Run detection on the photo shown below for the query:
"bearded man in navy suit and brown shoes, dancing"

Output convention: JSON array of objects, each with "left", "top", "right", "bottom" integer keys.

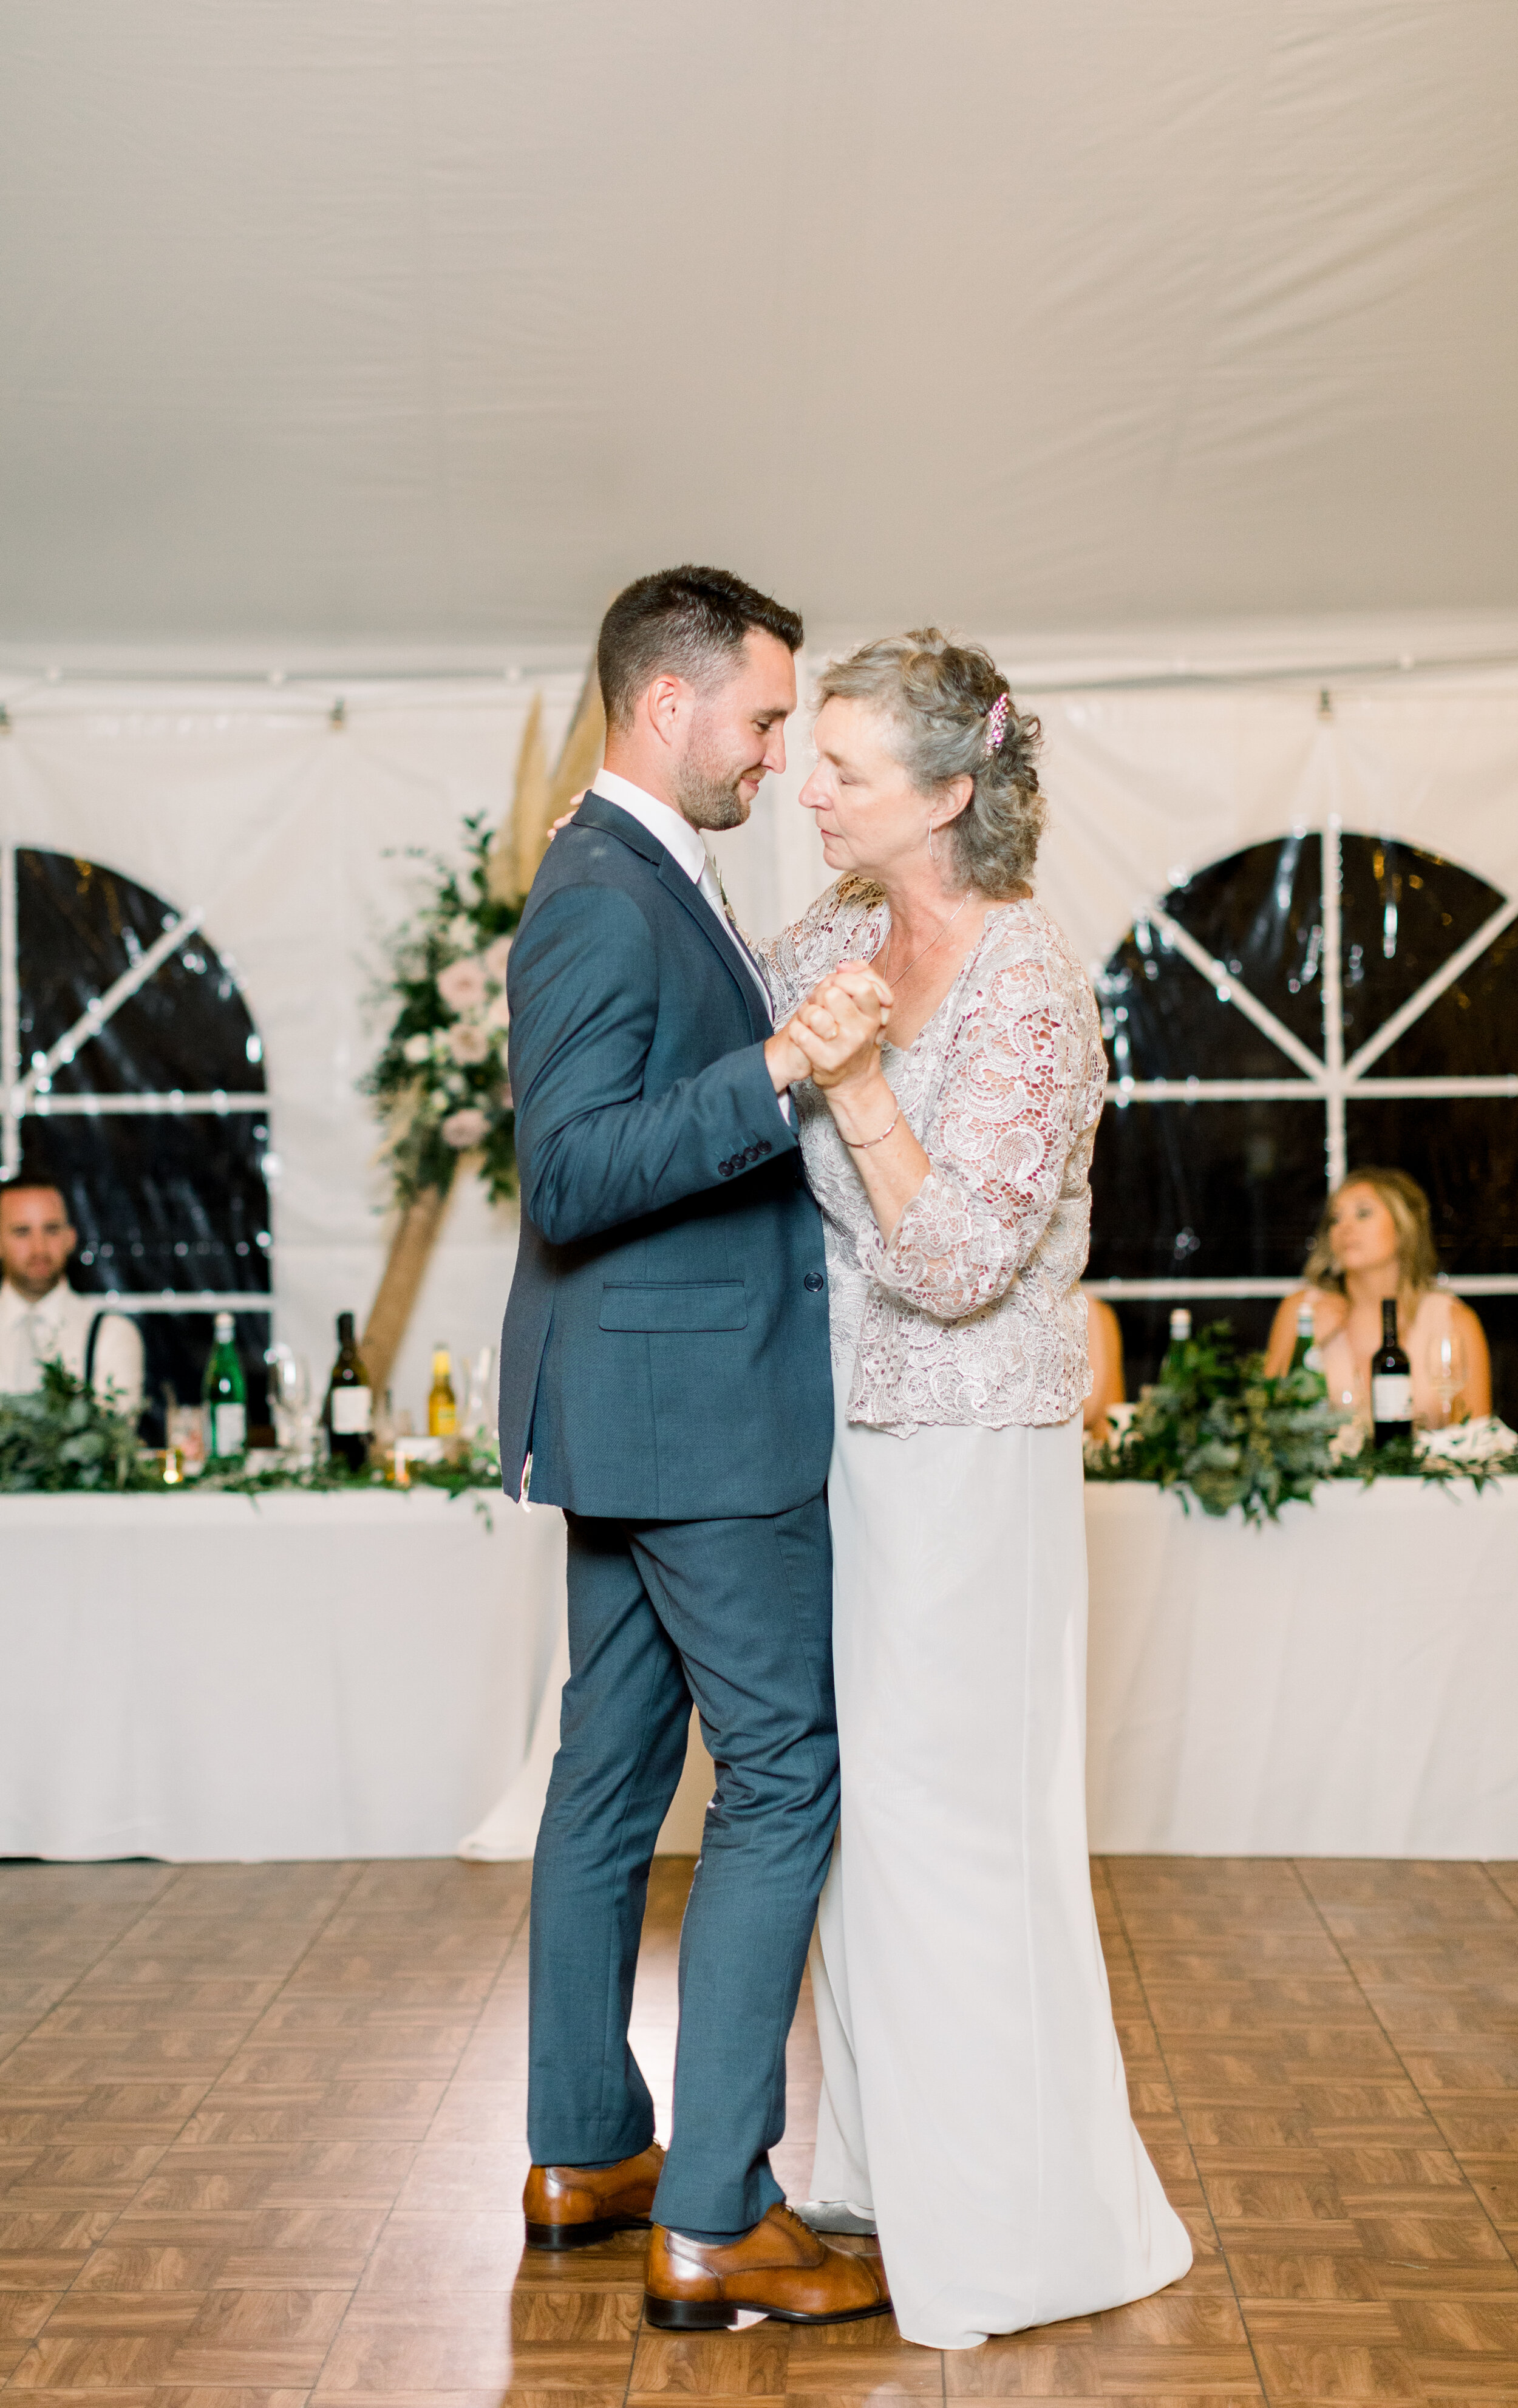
[{"left": 501, "top": 568, "right": 887, "bottom": 2331}]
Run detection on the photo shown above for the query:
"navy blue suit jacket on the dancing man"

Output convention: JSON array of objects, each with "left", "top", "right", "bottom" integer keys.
[{"left": 501, "top": 792, "right": 834, "bottom": 1522}]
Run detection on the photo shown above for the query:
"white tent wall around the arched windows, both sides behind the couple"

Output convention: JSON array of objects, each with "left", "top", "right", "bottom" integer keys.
[{"left": 0, "top": 626, "right": 1518, "bottom": 1411}]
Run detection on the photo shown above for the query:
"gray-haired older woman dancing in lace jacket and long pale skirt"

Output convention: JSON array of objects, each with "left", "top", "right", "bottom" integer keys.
[{"left": 766, "top": 628, "right": 1190, "bottom": 2348}]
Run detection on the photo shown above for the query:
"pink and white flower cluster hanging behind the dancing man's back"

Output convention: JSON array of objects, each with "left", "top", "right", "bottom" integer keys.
[{"left": 364, "top": 814, "right": 523, "bottom": 1209}]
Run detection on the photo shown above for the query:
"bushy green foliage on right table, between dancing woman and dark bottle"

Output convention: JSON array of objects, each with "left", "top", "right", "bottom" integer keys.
[{"left": 1087, "top": 1322, "right": 1342, "bottom": 1522}]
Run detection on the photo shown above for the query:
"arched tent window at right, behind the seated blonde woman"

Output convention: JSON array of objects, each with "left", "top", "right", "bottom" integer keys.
[{"left": 1089, "top": 823, "right": 1518, "bottom": 1418}]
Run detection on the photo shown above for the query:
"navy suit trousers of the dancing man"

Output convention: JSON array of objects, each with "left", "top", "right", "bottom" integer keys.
[{"left": 528, "top": 1495, "right": 839, "bottom": 2237}]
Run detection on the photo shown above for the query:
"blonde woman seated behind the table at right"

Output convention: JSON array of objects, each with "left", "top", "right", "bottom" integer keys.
[{"left": 1265, "top": 1168, "right": 1491, "bottom": 1430}]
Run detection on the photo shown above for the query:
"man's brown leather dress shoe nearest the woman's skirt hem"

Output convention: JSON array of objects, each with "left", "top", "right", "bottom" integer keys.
[{"left": 644, "top": 2208, "right": 891, "bottom": 2333}]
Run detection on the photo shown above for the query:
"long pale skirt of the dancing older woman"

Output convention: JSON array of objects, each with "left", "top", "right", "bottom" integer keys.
[{"left": 812, "top": 1421, "right": 1190, "bottom": 2350}]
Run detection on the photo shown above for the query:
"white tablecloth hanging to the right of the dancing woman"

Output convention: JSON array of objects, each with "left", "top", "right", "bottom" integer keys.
[{"left": 1087, "top": 1481, "right": 1518, "bottom": 1857}]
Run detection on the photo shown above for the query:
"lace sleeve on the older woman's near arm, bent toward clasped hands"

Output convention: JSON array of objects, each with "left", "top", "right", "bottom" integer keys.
[{"left": 860, "top": 954, "right": 1106, "bottom": 1322}]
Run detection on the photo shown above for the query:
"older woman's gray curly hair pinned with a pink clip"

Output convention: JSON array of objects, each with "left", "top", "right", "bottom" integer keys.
[{"left": 817, "top": 626, "right": 1046, "bottom": 900}]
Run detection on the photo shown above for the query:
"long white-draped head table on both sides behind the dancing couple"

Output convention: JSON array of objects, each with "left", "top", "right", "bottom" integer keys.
[{"left": 0, "top": 1481, "right": 1518, "bottom": 1862}]
